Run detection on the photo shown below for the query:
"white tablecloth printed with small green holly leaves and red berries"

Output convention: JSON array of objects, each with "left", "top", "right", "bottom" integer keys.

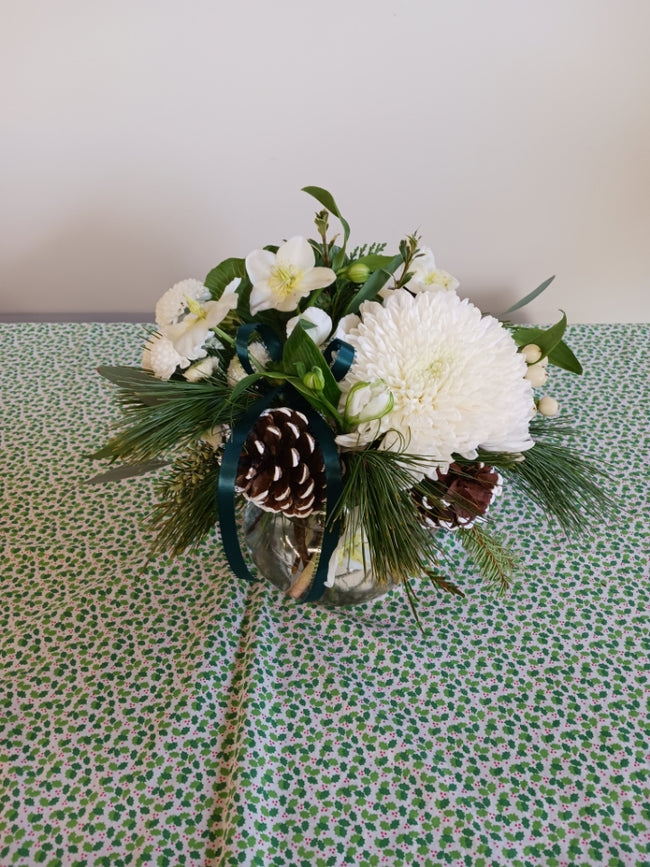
[{"left": 0, "top": 323, "right": 650, "bottom": 867}]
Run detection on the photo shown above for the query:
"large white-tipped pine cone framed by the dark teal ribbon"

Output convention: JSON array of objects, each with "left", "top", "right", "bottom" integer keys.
[{"left": 235, "top": 406, "right": 327, "bottom": 518}]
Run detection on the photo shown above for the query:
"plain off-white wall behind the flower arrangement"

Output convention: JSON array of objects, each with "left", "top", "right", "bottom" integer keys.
[{"left": 0, "top": 0, "right": 650, "bottom": 322}]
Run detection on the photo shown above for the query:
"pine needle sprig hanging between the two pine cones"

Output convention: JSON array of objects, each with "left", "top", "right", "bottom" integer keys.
[{"left": 332, "top": 449, "right": 439, "bottom": 583}]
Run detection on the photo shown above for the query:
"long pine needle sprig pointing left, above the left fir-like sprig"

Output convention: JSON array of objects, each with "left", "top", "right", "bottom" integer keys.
[{"left": 91, "top": 367, "right": 251, "bottom": 463}]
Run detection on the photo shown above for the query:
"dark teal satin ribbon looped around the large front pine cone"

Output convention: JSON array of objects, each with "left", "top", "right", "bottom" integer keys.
[{"left": 217, "top": 323, "right": 354, "bottom": 602}]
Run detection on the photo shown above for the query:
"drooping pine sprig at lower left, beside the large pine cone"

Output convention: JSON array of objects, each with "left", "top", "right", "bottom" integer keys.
[{"left": 149, "top": 442, "right": 220, "bottom": 557}]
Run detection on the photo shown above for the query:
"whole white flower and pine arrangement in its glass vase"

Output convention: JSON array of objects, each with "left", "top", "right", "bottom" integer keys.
[{"left": 93, "top": 187, "right": 609, "bottom": 602}]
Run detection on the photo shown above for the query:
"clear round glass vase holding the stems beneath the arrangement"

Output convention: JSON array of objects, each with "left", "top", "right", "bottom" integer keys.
[{"left": 243, "top": 502, "right": 395, "bottom": 607}]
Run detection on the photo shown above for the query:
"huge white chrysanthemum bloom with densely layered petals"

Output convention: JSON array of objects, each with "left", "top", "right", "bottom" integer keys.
[{"left": 341, "top": 289, "right": 534, "bottom": 468}]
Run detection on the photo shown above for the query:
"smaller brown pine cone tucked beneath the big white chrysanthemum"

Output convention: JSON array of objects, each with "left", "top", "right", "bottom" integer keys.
[{"left": 411, "top": 463, "right": 502, "bottom": 530}]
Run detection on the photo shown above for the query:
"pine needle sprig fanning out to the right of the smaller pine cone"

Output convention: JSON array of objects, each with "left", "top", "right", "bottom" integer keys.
[{"left": 502, "top": 419, "right": 617, "bottom": 535}]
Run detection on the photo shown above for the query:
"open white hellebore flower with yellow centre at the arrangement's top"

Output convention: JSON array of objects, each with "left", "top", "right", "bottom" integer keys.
[{"left": 246, "top": 235, "right": 336, "bottom": 313}]
